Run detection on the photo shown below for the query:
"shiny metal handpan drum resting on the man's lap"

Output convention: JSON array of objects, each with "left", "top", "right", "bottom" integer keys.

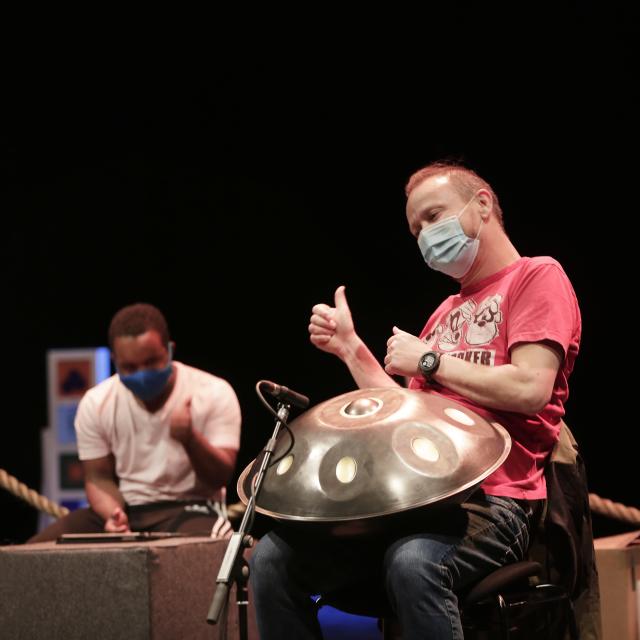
[{"left": 238, "top": 387, "right": 511, "bottom": 535}]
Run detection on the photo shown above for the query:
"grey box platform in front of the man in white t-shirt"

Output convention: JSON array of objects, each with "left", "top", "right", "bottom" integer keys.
[{"left": 0, "top": 538, "right": 258, "bottom": 640}]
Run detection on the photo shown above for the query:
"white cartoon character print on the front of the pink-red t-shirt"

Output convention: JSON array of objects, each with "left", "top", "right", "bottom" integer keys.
[{"left": 423, "top": 293, "right": 503, "bottom": 366}]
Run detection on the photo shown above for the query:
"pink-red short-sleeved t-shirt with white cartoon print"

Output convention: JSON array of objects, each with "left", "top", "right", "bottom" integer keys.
[{"left": 409, "top": 257, "right": 582, "bottom": 500}]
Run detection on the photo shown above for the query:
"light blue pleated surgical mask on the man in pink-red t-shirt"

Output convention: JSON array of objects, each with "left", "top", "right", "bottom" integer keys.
[{"left": 418, "top": 194, "right": 482, "bottom": 279}]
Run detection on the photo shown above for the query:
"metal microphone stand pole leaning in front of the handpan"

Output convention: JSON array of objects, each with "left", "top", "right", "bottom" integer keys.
[{"left": 207, "top": 402, "right": 291, "bottom": 640}]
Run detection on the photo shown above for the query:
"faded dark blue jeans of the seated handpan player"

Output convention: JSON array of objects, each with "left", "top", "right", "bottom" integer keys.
[{"left": 250, "top": 492, "right": 532, "bottom": 640}]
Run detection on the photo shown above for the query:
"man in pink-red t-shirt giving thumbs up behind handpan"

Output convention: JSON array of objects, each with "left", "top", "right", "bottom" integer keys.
[{"left": 252, "top": 163, "right": 581, "bottom": 639}]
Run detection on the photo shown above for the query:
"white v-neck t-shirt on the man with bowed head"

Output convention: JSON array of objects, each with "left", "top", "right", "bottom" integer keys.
[{"left": 75, "top": 361, "right": 241, "bottom": 504}]
